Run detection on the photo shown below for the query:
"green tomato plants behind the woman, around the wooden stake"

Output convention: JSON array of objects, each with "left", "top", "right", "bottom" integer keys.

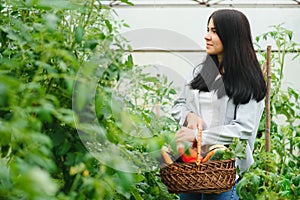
[{"left": 237, "top": 24, "right": 300, "bottom": 200}]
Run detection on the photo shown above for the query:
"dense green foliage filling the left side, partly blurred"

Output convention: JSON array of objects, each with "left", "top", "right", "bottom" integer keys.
[{"left": 0, "top": 0, "right": 176, "bottom": 200}]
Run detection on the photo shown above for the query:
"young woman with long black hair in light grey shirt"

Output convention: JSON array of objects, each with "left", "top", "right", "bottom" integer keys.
[{"left": 173, "top": 9, "right": 266, "bottom": 200}]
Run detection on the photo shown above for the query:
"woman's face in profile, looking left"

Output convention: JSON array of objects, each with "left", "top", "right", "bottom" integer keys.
[{"left": 204, "top": 18, "right": 223, "bottom": 62}]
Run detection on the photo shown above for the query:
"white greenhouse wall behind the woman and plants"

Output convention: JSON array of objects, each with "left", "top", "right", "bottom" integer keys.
[{"left": 114, "top": 1, "right": 300, "bottom": 91}]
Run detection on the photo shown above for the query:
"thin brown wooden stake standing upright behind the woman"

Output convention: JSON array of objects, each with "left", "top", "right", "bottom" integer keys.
[{"left": 266, "top": 45, "right": 272, "bottom": 152}]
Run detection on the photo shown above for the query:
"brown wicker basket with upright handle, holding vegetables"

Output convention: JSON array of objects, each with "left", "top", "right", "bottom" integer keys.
[{"left": 160, "top": 129, "right": 236, "bottom": 193}]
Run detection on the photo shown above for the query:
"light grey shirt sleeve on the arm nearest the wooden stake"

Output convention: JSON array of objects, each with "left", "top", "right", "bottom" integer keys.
[{"left": 202, "top": 99, "right": 264, "bottom": 146}]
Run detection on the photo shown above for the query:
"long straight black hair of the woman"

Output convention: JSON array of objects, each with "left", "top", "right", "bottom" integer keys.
[{"left": 190, "top": 9, "right": 266, "bottom": 105}]
